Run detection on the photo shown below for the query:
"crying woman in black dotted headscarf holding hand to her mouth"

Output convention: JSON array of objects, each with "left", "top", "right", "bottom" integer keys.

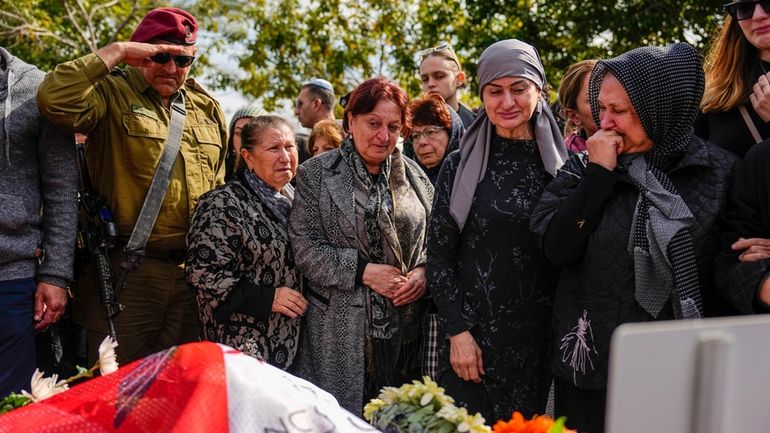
[{"left": 532, "top": 44, "right": 734, "bottom": 433}]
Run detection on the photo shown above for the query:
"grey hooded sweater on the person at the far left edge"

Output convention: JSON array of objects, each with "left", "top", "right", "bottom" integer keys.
[{"left": 0, "top": 47, "right": 78, "bottom": 287}]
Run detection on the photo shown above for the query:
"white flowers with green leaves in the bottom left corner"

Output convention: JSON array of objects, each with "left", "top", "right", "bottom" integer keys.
[{"left": 0, "top": 336, "right": 118, "bottom": 414}]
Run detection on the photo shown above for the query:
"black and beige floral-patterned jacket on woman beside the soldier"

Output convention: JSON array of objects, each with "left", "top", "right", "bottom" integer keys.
[{"left": 186, "top": 179, "right": 302, "bottom": 369}]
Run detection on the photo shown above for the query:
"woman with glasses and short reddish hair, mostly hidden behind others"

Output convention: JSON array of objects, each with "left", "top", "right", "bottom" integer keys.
[{"left": 409, "top": 93, "right": 465, "bottom": 185}]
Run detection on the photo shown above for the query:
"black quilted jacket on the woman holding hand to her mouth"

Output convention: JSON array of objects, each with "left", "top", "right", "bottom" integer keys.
[{"left": 531, "top": 136, "right": 735, "bottom": 389}]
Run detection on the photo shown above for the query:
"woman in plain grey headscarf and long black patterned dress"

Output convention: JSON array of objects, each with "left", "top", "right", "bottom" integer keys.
[{"left": 428, "top": 39, "right": 567, "bottom": 420}]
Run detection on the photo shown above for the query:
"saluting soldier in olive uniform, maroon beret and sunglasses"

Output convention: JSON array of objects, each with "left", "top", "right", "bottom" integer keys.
[{"left": 37, "top": 8, "right": 227, "bottom": 363}]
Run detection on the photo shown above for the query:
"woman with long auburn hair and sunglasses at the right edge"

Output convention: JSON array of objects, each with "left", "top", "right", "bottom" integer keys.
[{"left": 695, "top": 0, "right": 770, "bottom": 158}]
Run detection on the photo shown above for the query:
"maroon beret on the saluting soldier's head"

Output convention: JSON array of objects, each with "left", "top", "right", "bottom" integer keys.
[{"left": 131, "top": 8, "right": 198, "bottom": 45}]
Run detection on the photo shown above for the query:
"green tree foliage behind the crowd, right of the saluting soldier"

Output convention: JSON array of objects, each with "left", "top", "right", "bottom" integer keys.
[{"left": 194, "top": 0, "right": 723, "bottom": 108}]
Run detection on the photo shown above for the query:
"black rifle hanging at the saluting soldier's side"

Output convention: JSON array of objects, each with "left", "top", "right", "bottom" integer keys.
[{"left": 75, "top": 139, "right": 125, "bottom": 341}]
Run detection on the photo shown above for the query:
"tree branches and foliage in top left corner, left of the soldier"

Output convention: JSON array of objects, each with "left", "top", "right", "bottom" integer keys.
[{"left": 0, "top": 0, "right": 160, "bottom": 70}]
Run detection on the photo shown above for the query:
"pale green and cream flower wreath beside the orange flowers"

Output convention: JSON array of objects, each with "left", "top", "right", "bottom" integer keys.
[{"left": 364, "top": 376, "right": 491, "bottom": 433}]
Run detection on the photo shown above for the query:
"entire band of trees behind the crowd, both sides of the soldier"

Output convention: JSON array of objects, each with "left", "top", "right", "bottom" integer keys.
[{"left": 0, "top": 0, "right": 724, "bottom": 110}]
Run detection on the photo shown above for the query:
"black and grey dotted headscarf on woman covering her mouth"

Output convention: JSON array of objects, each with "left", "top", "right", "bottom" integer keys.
[{"left": 588, "top": 43, "right": 704, "bottom": 318}]
